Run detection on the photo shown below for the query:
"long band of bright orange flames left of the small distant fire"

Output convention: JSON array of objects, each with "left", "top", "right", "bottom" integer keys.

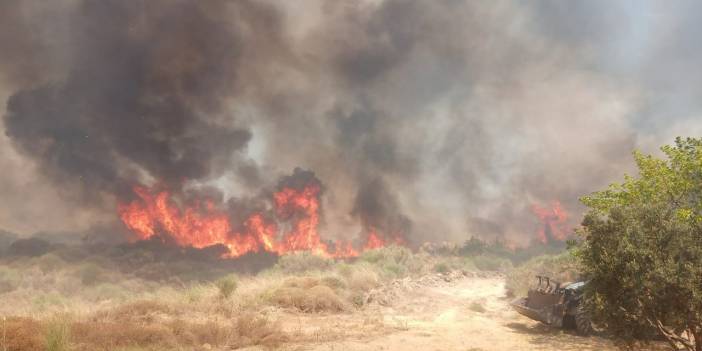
[{"left": 118, "top": 184, "right": 404, "bottom": 258}]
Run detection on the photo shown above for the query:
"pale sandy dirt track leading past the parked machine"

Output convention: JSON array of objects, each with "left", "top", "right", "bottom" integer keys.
[{"left": 280, "top": 277, "right": 632, "bottom": 351}]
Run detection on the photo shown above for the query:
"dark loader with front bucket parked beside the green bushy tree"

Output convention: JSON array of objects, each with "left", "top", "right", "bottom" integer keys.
[{"left": 511, "top": 276, "right": 593, "bottom": 336}]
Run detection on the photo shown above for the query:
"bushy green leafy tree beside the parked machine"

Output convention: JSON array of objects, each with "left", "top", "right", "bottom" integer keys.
[{"left": 576, "top": 138, "right": 702, "bottom": 350}]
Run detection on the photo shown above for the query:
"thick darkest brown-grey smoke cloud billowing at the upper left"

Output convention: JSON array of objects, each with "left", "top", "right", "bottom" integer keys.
[{"left": 5, "top": 1, "right": 288, "bottom": 199}]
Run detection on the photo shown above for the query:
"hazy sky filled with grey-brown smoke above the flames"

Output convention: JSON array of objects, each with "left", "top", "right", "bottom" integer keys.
[{"left": 0, "top": 0, "right": 702, "bottom": 243}]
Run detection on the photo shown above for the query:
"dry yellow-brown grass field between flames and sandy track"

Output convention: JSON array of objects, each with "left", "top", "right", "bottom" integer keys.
[{"left": 0, "top": 248, "right": 496, "bottom": 351}]
